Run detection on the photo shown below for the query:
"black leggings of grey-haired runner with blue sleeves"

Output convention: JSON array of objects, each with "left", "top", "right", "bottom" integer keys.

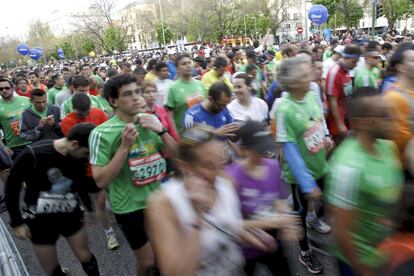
[{"left": 290, "top": 178, "right": 324, "bottom": 251}]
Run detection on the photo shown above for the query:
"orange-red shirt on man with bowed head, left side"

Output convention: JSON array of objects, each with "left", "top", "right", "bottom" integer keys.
[{"left": 60, "top": 107, "right": 108, "bottom": 136}]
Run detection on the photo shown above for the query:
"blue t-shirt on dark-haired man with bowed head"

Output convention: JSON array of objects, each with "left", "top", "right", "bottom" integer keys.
[{"left": 184, "top": 103, "right": 233, "bottom": 129}]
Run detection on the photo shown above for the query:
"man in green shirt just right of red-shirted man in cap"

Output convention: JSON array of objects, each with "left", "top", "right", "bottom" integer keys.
[{"left": 354, "top": 48, "right": 381, "bottom": 88}]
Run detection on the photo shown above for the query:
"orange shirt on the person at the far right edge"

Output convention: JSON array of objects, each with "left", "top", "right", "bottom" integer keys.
[{"left": 384, "top": 84, "right": 414, "bottom": 164}]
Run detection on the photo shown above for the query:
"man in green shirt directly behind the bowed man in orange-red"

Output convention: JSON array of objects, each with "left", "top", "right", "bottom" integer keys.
[{"left": 60, "top": 75, "right": 104, "bottom": 119}]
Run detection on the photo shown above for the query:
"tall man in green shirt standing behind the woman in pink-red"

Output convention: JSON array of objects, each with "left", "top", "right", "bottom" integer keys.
[{"left": 166, "top": 54, "right": 206, "bottom": 135}]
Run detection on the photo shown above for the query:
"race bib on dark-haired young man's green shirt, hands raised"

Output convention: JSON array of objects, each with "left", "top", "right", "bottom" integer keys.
[{"left": 128, "top": 152, "right": 167, "bottom": 186}]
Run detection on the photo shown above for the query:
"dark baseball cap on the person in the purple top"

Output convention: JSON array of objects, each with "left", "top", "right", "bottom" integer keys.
[{"left": 236, "top": 120, "right": 276, "bottom": 154}]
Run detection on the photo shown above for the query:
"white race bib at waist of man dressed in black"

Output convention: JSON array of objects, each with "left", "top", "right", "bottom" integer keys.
[{"left": 36, "top": 192, "right": 79, "bottom": 214}]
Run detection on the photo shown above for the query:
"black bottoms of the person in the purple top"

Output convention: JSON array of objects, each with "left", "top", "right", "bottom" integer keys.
[{"left": 244, "top": 242, "right": 291, "bottom": 276}]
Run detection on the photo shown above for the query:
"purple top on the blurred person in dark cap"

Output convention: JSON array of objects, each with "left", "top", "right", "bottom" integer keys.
[{"left": 225, "top": 158, "right": 287, "bottom": 258}]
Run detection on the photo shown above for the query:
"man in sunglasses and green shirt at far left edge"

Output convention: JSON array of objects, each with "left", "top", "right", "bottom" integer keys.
[{"left": 0, "top": 79, "right": 31, "bottom": 158}]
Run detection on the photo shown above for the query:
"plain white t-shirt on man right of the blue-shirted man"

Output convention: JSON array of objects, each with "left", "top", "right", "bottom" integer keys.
[{"left": 227, "top": 97, "right": 269, "bottom": 122}]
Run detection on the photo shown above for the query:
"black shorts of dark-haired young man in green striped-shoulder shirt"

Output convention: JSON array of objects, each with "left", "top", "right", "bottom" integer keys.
[{"left": 115, "top": 209, "right": 148, "bottom": 251}]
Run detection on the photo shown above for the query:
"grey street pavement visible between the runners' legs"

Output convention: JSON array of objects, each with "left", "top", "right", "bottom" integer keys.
[{"left": 0, "top": 210, "right": 338, "bottom": 276}]
